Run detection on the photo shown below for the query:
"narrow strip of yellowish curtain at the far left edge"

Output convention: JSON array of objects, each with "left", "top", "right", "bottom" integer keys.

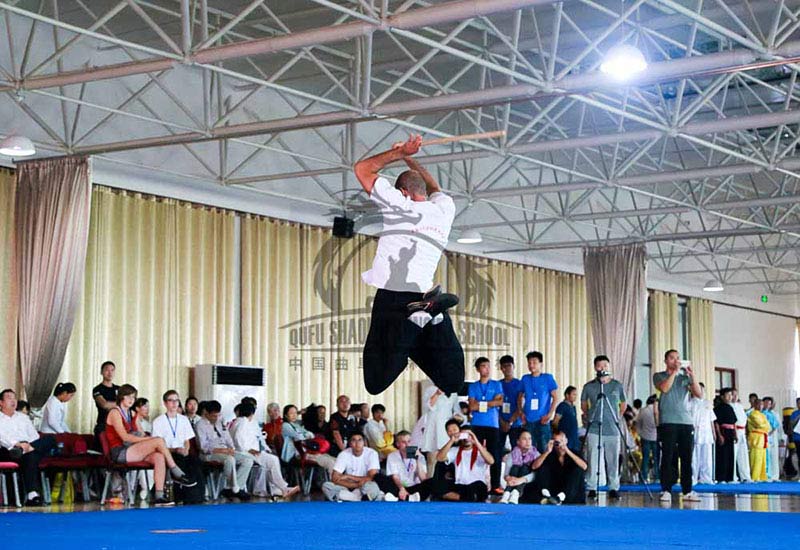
[{"left": 0, "top": 168, "right": 20, "bottom": 390}]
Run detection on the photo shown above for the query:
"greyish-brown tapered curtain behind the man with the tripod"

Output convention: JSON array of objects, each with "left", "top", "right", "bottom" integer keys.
[{"left": 583, "top": 244, "right": 647, "bottom": 395}]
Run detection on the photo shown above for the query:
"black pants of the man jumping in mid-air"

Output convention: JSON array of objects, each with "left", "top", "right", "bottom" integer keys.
[{"left": 363, "top": 289, "right": 464, "bottom": 395}]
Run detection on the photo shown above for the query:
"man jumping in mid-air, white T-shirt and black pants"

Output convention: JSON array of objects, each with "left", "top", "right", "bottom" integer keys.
[{"left": 355, "top": 136, "right": 464, "bottom": 395}]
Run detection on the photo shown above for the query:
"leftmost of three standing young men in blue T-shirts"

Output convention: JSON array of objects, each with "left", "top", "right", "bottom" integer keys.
[{"left": 468, "top": 357, "right": 503, "bottom": 495}]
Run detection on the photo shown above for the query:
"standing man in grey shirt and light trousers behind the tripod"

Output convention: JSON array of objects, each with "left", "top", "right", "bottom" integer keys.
[{"left": 581, "top": 355, "right": 625, "bottom": 499}]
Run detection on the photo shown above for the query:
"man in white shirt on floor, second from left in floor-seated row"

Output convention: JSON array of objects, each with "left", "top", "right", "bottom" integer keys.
[{"left": 380, "top": 432, "right": 433, "bottom": 502}]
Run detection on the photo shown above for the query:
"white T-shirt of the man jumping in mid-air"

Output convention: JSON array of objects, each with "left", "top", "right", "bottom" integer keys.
[{"left": 361, "top": 177, "right": 456, "bottom": 292}]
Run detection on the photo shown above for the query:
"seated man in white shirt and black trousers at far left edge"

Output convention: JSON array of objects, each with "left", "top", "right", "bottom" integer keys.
[{"left": 0, "top": 389, "right": 56, "bottom": 506}]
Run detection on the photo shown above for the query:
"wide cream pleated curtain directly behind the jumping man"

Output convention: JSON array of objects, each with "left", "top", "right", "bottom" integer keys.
[{"left": 242, "top": 222, "right": 591, "bottom": 429}]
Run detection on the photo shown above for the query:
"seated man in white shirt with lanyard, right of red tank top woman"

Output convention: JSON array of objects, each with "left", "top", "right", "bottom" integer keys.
[{"left": 152, "top": 390, "right": 205, "bottom": 504}]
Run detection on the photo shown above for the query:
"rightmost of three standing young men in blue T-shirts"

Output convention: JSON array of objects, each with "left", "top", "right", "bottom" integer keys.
[{"left": 517, "top": 351, "right": 558, "bottom": 453}]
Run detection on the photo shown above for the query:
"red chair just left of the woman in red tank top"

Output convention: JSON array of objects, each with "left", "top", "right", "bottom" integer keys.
[{"left": 39, "top": 433, "right": 107, "bottom": 504}]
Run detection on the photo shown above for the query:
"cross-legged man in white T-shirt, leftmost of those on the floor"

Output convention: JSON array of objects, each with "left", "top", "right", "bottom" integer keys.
[{"left": 322, "top": 432, "right": 383, "bottom": 502}]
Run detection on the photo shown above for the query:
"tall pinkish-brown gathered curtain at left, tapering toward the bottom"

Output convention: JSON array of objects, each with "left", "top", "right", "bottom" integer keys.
[{"left": 16, "top": 158, "right": 92, "bottom": 407}]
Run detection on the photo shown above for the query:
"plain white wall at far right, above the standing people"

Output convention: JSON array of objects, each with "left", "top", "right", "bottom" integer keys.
[{"left": 714, "top": 304, "right": 800, "bottom": 407}]
